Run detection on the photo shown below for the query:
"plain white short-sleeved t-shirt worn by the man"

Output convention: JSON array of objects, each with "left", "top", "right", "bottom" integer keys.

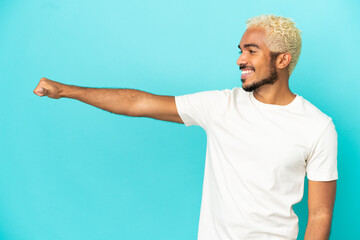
[{"left": 175, "top": 87, "right": 338, "bottom": 240}]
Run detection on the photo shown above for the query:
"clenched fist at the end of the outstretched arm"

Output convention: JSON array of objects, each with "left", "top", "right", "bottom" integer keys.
[{"left": 33, "top": 77, "right": 64, "bottom": 99}]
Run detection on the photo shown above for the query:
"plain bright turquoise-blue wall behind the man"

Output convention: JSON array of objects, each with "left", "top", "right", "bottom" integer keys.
[{"left": 0, "top": 0, "right": 360, "bottom": 240}]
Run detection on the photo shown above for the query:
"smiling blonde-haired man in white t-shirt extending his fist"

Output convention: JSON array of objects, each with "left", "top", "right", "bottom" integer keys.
[{"left": 34, "top": 15, "right": 338, "bottom": 240}]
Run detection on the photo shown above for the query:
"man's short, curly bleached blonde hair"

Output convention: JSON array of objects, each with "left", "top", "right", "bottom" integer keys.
[{"left": 246, "top": 14, "right": 301, "bottom": 75}]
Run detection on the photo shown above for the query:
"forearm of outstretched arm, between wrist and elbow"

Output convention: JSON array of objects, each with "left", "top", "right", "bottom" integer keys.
[{"left": 60, "top": 84, "right": 149, "bottom": 116}]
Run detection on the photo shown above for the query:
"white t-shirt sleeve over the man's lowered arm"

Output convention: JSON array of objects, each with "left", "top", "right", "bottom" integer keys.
[{"left": 306, "top": 120, "right": 338, "bottom": 181}]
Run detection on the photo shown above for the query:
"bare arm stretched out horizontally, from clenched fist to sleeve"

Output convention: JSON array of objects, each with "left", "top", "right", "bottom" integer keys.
[{"left": 34, "top": 78, "right": 183, "bottom": 123}]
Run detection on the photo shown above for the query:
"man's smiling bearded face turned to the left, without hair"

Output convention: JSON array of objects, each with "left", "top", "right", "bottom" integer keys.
[{"left": 236, "top": 27, "right": 278, "bottom": 92}]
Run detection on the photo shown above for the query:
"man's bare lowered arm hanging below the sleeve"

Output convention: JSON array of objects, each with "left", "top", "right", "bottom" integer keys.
[{"left": 305, "top": 180, "right": 336, "bottom": 240}]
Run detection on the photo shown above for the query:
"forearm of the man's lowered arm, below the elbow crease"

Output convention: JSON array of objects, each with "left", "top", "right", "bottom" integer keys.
[{"left": 304, "top": 215, "right": 331, "bottom": 240}]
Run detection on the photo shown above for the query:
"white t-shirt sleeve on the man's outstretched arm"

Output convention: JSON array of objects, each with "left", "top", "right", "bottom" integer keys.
[{"left": 175, "top": 90, "right": 226, "bottom": 129}]
